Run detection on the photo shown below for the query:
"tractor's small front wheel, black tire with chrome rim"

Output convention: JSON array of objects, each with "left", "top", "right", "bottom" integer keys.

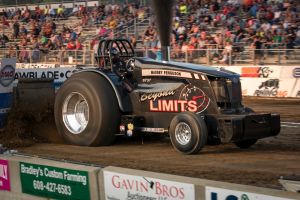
[{"left": 169, "top": 112, "right": 208, "bottom": 154}]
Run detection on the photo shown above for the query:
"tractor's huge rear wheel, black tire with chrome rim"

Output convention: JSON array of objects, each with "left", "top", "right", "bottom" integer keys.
[{"left": 54, "top": 72, "right": 121, "bottom": 146}]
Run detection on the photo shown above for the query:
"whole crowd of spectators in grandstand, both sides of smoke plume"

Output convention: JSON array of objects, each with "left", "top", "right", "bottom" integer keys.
[{"left": 0, "top": 0, "right": 300, "bottom": 63}]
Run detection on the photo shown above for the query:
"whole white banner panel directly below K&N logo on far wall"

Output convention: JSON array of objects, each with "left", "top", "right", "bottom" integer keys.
[{"left": 241, "top": 78, "right": 296, "bottom": 97}]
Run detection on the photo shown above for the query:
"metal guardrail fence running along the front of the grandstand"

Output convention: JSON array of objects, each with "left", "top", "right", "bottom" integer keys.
[{"left": 0, "top": 48, "right": 300, "bottom": 66}]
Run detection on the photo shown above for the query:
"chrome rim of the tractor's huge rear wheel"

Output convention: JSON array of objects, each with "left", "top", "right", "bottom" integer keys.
[{"left": 62, "top": 92, "right": 89, "bottom": 135}]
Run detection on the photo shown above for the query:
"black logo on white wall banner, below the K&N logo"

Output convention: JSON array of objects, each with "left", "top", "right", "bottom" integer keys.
[{"left": 254, "top": 79, "right": 288, "bottom": 97}]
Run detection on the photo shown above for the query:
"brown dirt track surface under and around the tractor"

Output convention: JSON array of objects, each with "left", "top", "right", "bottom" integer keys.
[{"left": 5, "top": 97, "right": 300, "bottom": 188}]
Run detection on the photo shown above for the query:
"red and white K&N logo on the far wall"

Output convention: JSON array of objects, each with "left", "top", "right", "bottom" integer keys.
[{"left": 241, "top": 67, "right": 274, "bottom": 78}]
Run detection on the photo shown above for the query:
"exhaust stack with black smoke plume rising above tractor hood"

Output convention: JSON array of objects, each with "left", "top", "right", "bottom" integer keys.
[{"left": 152, "top": 0, "right": 175, "bottom": 61}]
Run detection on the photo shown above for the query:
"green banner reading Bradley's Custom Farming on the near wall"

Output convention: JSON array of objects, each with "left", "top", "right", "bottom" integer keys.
[{"left": 20, "top": 162, "right": 90, "bottom": 200}]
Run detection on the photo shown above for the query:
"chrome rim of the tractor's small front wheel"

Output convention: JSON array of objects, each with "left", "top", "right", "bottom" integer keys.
[{"left": 175, "top": 122, "right": 192, "bottom": 145}]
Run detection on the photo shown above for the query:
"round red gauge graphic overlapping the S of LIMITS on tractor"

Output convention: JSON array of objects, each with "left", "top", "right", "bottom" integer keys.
[{"left": 179, "top": 85, "right": 210, "bottom": 113}]
